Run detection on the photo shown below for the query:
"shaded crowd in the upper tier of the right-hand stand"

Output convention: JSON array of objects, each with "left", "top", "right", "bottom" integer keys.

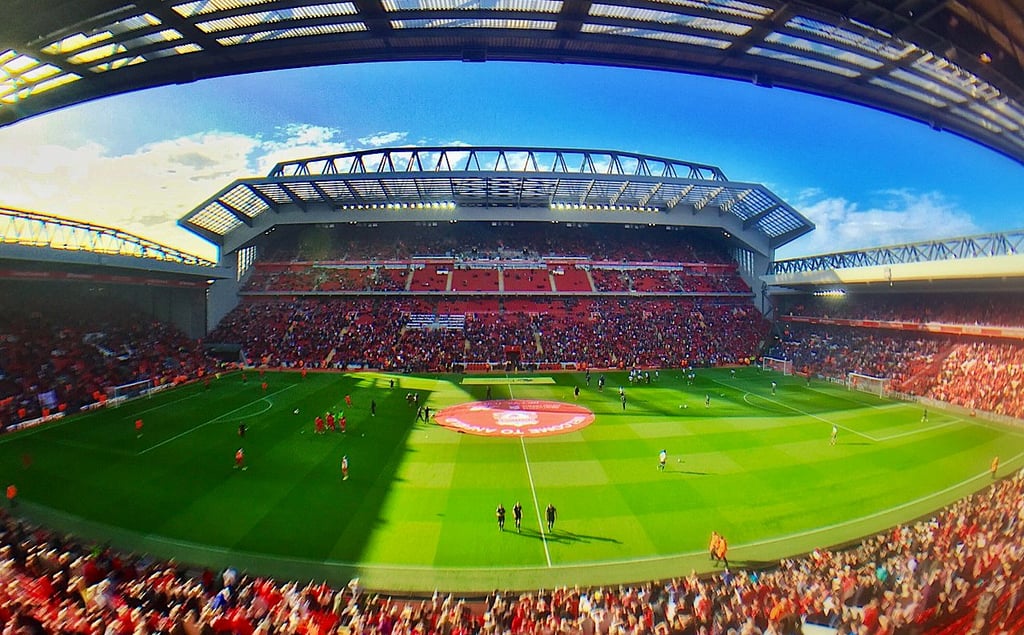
[{"left": 778, "top": 293, "right": 1024, "bottom": 327}]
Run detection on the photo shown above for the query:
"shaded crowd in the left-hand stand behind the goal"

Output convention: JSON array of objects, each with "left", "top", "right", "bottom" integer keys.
[{"left": 0, "top": 289, "right": 212, "bottom": 430}]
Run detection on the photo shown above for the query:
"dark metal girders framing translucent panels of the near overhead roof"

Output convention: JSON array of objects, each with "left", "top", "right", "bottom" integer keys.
[{"left": 0, "top": 0, "right": 1024, "bottom": 171}]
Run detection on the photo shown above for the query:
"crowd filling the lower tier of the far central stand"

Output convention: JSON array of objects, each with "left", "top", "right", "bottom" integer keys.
[{"left": 208, "top": 296, "right": 768, "bottom": 371}]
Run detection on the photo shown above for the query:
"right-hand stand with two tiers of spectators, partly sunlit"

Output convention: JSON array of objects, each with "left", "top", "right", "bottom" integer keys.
[{"left": 769, "top": 294, "right": 1024, "bottom": 419}]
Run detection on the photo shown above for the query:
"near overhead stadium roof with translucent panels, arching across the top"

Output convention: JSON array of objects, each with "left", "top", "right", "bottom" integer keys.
[{"left": 0, "top": 0, "right": 1024, "bottom": 162}]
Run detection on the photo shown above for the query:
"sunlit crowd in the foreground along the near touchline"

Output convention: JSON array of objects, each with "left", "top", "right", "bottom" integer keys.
[{"left": 0, "top": 462, "right": 1024, "bottom": 635}]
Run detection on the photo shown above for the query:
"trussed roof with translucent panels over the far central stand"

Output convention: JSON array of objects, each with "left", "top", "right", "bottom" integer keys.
[{"left": 178, "top": 146, "right": 814, "bottom": 255}]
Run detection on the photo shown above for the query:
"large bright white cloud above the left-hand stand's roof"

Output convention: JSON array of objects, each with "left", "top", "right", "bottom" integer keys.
[{"left": 0, "top": 124, "right": 404, "bottom": 258}]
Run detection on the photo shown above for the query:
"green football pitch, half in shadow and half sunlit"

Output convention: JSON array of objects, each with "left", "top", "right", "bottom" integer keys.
[{"left": 0, "top": 368, "right": 1024, "bottom": 592}]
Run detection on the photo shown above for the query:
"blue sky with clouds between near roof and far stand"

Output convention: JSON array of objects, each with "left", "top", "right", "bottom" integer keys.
[{"left": 0, "top": 58, "right": 1024, "bottom": 257}]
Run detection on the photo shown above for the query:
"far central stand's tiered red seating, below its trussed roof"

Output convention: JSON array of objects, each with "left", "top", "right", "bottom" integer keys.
[{"left": 208, "top": 222, "right": 767, "bottom": 371}]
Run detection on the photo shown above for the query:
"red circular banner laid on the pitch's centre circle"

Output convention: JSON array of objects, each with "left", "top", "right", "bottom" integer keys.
[{"left": 434, "top": 399, "right": 594, "bottom": 436}]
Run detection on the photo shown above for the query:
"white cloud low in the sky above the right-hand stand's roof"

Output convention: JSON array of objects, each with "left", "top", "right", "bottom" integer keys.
[{"left": 777, "top": 189, "right": 981, "bottom": 258}]
